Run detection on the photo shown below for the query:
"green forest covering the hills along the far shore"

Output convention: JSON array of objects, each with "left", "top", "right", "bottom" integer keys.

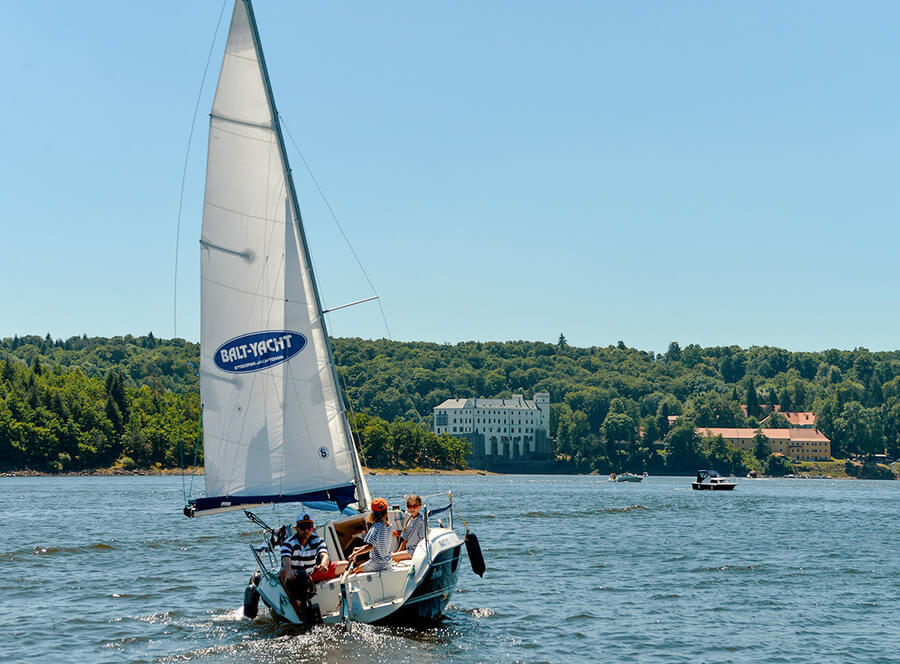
[{"left": 0, "top": 333, "right": 900, "bottom": 474}]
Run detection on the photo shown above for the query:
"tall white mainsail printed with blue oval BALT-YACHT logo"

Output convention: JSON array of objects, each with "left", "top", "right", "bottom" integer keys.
[{"left": 186, "top": 0, "right": 369, "bottom": 515}]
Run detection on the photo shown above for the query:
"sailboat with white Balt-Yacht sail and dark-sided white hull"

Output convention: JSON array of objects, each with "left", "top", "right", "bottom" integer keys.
[{"left": 184, "top": 0, "right": 483, "bottom": 625}]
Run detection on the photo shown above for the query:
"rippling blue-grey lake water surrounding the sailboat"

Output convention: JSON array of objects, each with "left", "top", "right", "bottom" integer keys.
[{"left": 0, "top": 476, "right": 900, "bottom": 664}]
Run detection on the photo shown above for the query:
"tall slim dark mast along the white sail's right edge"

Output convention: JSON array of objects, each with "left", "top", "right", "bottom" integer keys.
[{"left": 239, "top": 0, "right": 369, "bottom": 511}]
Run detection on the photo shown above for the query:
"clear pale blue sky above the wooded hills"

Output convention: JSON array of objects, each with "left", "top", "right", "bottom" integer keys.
[{"left": 0, "top": 0, "right": 900, "bottom": 352}]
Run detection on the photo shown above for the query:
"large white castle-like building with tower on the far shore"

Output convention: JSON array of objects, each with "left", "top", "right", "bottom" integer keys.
[{"left": 434, "top": 392, "right": 550, "bottom": 459}]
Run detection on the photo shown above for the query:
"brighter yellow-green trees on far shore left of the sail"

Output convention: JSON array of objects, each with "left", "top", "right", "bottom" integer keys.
[{"left": 0, "top": 337, "right": 200, "bottom": 472}]
